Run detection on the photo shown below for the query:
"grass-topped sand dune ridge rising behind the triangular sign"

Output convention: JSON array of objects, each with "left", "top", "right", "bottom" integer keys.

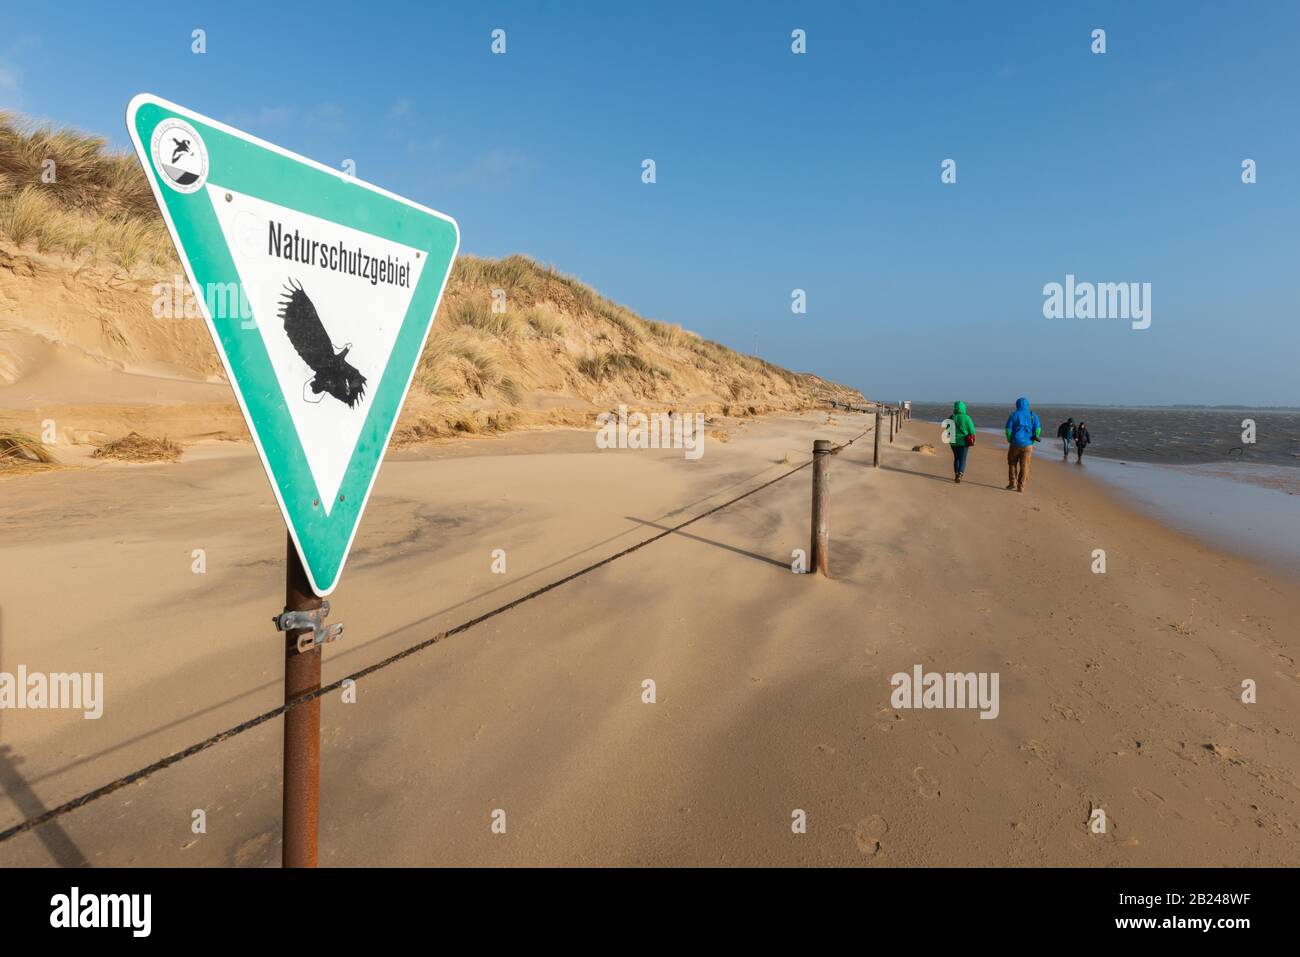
[{"left": 0, "top": 111, "right": 862, "bottom": 468}]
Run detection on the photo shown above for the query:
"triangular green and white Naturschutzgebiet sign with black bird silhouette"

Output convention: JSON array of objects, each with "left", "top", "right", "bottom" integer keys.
[{"left": 126, "top": 94, "right": 460, "bottom": 596}]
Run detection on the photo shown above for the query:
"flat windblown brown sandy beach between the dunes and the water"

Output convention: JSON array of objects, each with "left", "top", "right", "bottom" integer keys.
[{"left": 0, "top": 412, "right": 1300, "bottom": 866}]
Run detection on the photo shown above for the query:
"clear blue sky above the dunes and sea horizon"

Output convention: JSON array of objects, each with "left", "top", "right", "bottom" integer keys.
[{"left": 0, "top": 0, "right": 1300, "bottom": 404}]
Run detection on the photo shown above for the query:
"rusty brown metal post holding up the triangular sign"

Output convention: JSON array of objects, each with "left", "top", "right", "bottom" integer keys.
[{"left": 281, "top": 534, "right": 321, "bottom": 867}]
